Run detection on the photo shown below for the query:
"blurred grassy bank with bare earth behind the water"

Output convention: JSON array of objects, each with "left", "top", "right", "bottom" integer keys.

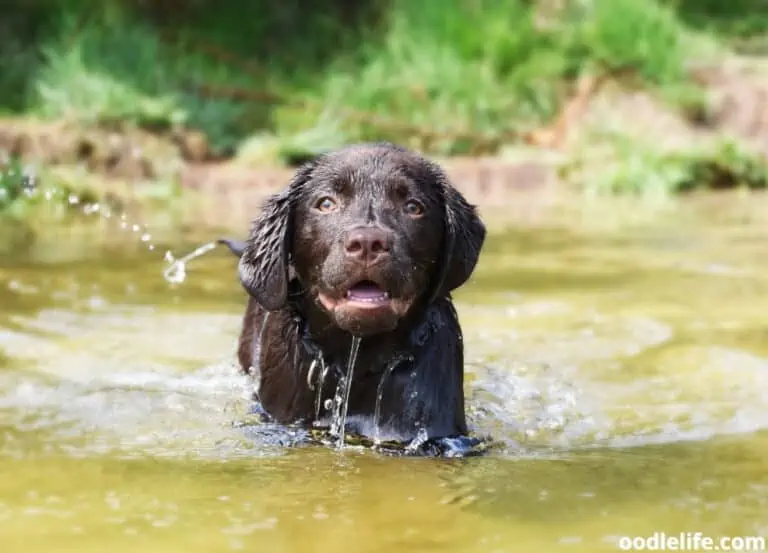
[{"left": 0, "top": 0, "right": 768, "bottom": 215}]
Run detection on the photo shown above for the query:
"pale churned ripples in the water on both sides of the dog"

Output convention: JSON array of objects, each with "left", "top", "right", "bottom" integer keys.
[{"left": 0, "top": 296, "right": 768, "bottom": 458}]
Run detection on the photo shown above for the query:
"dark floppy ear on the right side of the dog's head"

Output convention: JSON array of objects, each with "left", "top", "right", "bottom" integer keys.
[{"left": 431, "top": 172, "right": 486, "bottom": 300}]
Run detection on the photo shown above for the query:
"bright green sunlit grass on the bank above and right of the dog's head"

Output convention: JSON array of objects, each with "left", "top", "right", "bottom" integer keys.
[{"left": 276, "top": 0, "right": 702, "bottom": 154}]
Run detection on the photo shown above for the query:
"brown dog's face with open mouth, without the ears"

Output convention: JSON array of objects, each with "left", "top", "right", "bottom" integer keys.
[{"left": 293, "top": 150, "right": 445, "bottom": 336}]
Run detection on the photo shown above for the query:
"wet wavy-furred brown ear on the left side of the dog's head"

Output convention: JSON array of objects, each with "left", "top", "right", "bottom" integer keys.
[{"left": 238, "top": 163, "right": 315, "bottom": 311}]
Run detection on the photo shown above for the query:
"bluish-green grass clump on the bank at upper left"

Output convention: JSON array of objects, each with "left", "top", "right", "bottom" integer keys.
[{"left": 30, "top": 8, "right": 252, "bottom": 155}]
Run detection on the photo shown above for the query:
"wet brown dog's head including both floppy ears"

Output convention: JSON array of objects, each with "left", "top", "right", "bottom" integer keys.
[{"left": 239, "top": 144, "right": 485, "bottom": 336}]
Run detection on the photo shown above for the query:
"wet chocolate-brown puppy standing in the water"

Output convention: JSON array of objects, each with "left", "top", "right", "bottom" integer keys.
[{"left": 222, "top": 143, "right": 486, "bottom": 450}]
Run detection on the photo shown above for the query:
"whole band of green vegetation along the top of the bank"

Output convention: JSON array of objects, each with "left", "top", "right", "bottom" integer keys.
[{"left": 0, "top": 0, "right": 768, "bottom": 201}]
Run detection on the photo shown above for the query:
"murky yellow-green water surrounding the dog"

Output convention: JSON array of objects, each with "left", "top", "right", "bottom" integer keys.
[{"left": 0, "top": 192, "right": 768, "bottom": 553}]
